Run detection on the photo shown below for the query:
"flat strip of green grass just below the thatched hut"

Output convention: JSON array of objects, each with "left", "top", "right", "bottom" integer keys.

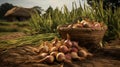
[{"left": 0, "top": 21, "right": 29, "bottom": 32}]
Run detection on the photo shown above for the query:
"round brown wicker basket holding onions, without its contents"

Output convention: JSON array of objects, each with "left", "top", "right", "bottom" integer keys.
[{"left": 57, "top": 25, "right": 107, "bottom": 44}]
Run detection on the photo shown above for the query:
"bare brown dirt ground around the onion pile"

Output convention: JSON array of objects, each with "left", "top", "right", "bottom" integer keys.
[{"left": 0, "top": 33, "right": 120, "bottom": 67}]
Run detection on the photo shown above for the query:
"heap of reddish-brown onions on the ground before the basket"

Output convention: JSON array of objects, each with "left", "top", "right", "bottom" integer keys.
[{"left": 39, "top": 34, "right": 92, "bottom": 64}]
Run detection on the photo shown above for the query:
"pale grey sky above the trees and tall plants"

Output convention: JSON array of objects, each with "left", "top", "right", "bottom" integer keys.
[{"left": 0, "top": 0, "right": 86, "bottom": 10}]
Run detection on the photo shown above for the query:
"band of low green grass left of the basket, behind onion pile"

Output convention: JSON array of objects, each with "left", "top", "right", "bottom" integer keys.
[{"left": 0, "top": 33, "right": 58, "bottom": 49}]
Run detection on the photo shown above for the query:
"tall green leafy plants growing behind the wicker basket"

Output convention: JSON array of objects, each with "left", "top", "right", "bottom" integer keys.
[{"left": 30, "top": 0, "right": 120, "bottom": 40}]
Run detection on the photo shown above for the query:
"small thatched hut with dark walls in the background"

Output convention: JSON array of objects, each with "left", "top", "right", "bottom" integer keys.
[{"left": 4, "top": 7, "right": 34, "bottom": 21}]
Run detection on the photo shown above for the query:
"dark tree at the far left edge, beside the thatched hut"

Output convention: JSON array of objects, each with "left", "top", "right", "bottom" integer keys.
[{"left": 0, "top": 3, "right": 14, "bottom": 19}]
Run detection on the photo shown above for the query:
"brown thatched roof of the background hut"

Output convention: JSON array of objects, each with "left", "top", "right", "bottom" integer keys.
[{"left": 5, "top": 7, "right": 34, "bottom": 17}]
